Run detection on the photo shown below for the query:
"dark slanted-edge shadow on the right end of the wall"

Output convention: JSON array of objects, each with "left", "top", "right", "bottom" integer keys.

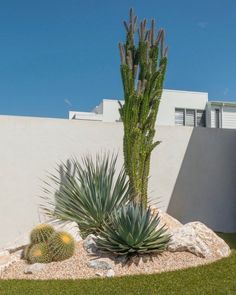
[{"left": 167, "top": 128, "right": 236, "bottom": 232}]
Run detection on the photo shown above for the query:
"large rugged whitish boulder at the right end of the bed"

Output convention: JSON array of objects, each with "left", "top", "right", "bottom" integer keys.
[{"left": 167, "top": 221, "right": 231, "bottom": 258}]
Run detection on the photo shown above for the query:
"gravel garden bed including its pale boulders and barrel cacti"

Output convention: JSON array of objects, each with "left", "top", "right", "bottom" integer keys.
[{"left": 0, "top": 214, "right": 230, "bottom": 280}]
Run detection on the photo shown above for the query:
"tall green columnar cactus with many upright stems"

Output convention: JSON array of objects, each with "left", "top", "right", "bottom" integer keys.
[{"left": 119, "top": 9, "right": 167, "bottom": 206}]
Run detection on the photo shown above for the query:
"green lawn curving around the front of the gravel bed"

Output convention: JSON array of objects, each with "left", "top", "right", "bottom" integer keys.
[{"left": 0, "top": 234, "right": 236, "bottom": 295}]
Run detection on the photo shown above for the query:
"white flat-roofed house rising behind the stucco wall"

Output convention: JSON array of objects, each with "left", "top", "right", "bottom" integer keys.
[{"left": 69, "top": 89, "right": 236, "bottom": 129}]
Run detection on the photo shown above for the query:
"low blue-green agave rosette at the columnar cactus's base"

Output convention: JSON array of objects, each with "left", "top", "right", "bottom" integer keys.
[{"left": 97, "top": 202, "right": 170, "bottom": 255}]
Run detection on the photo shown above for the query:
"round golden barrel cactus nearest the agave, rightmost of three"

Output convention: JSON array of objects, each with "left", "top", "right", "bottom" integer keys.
[{"left": 48, "top": 231, "right": 75, "bottom": 261}]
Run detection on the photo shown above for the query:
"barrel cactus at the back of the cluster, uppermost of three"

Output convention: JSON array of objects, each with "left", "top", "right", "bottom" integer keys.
[{"left": 30, "top": 224, "right": 55, "bottom": 244}]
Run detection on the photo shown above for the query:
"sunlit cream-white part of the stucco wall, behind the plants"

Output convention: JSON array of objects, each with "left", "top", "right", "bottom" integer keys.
[{"left": 0, "top": 116, "right": 192, "bottom": 248}]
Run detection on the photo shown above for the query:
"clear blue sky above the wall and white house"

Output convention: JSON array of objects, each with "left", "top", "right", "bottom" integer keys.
[{"left": 0, "top": 0, "right": 236, "bottom": 117}]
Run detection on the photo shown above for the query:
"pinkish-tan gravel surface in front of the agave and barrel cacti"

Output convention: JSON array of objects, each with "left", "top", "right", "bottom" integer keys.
[{"left": 0, "top": 237, "right": 229, "bottom": 280}]
